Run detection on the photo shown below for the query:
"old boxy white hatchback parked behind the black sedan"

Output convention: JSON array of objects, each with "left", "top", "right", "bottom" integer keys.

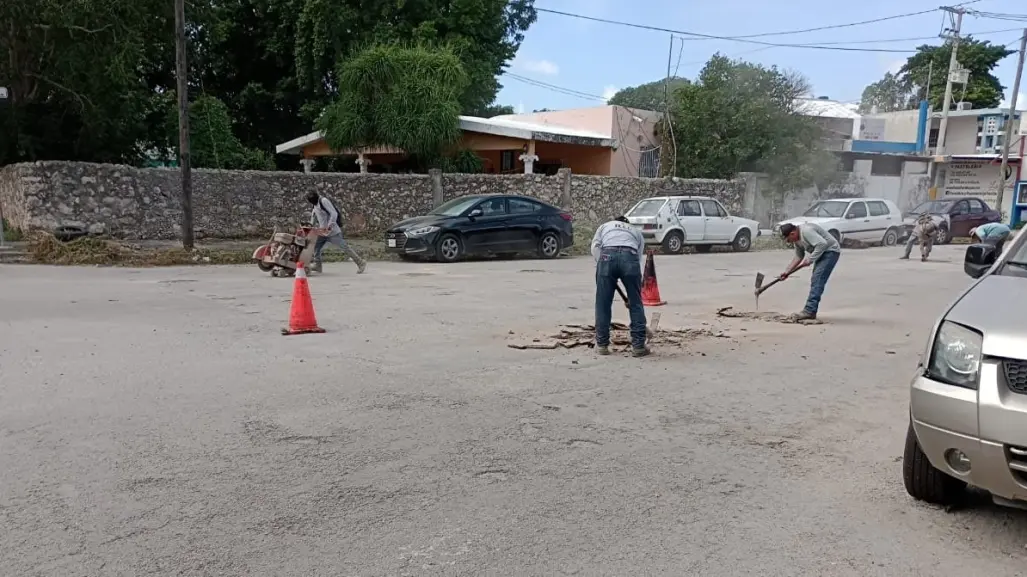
[{"left": 624, "top": 196, "right": 760, "bottom": 255}]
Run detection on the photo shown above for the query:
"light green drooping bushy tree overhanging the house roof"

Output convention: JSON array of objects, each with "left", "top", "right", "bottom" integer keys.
[{"left": 317, "top": 44, "right": 469, "bottom": 159}]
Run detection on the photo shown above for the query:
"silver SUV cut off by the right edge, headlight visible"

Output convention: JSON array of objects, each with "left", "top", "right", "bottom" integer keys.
[{"left": 903, "top": 226, "right": 1027, "bottom": 508}]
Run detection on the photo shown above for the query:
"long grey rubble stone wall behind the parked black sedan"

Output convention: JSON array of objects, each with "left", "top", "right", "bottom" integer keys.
[{"left": 0, "top": 162, "right": 746, "bottom": 239}]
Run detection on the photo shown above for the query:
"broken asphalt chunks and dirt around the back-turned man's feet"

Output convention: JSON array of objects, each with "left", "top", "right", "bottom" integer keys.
[{"left": 506, "top": 322, "right": 728, "bottom": 352}]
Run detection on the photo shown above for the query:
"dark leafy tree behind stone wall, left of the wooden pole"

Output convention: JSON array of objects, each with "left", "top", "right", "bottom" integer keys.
[{"left": 0, "top": 0, "right": 173, "bottom": 164}]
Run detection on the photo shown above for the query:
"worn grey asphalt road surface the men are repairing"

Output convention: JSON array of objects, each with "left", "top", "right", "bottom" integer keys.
[{"left": 0, "top": 246, "right": 1027, "bottom": 577}]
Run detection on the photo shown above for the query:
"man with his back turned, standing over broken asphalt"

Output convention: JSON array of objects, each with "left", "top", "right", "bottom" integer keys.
[{"left": 592, "top": 217, "right": 649, "bottom": 356}]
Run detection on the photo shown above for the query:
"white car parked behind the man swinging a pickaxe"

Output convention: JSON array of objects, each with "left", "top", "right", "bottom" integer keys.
[{"left": 774, "top": 198, "right": 903, "bottom": 246}]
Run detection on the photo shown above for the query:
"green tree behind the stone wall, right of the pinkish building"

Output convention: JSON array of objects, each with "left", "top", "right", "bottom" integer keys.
[{"left": 663, "top": 54, "right": 823, "bottom": 189}]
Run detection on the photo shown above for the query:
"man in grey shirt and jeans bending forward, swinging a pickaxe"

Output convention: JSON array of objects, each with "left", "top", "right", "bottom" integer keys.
[{"left": 778, "top": 223, "right": 841, "bottom": 320}]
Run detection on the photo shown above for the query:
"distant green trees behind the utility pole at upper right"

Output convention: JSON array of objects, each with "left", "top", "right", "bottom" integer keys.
[{"left": 860, "top": 37, "right": 1015, "bottom": 113}]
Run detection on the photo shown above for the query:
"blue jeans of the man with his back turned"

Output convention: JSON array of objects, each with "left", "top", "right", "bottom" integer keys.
[{"left": 596, "top": 248, "right": 645, "bottom": 349}]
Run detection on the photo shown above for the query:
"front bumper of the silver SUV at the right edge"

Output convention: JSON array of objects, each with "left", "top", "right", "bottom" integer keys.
[{"left": 910, "top": 360, "right": 1027, "bottom": 502}]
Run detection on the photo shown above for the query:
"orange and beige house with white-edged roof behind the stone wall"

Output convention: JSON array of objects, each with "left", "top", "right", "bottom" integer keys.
[{"left": 275, "top": 106, "right": 660, "bottom": 177}]
